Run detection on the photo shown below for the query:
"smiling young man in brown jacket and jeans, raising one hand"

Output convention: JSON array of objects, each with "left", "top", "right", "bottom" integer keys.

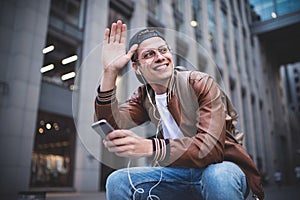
[{"left": 95, "top": 20, "right": 264, "bottom": 200}]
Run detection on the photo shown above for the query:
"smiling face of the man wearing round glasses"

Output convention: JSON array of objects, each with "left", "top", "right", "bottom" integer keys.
[{"left": 133, "top": 37, "right": 174, "bottom": 87}]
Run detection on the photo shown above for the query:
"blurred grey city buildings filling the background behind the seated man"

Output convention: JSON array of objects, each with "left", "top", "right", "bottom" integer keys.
[{"left": 0, "top": 0, "right": 300, "bottom": 199}]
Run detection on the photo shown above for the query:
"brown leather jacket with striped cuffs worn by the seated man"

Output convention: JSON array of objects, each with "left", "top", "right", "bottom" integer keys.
[{"left": 95, "top": 71, "right": 264, "bottom": 199}]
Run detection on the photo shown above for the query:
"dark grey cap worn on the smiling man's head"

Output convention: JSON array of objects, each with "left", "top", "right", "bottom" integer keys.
[{"left": 128, "top": 28, "right": 165, "bottom": 61}]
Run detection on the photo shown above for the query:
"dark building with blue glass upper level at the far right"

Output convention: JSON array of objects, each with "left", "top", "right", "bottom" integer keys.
[{"left": 249, "top": 0, "right": 300, "bottom": 183}]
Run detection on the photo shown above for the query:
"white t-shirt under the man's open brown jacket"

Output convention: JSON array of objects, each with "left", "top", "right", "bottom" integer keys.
[{"left": 155, "top": 93, "right": 184, "bottom": 139}]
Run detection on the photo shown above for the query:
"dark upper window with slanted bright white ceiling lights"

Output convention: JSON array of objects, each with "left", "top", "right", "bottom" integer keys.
[{"left": 41, "top": 0, "right": 85, "bottom": 90}]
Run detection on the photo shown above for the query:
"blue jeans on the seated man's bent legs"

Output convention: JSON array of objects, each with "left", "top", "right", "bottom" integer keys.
[{"left": 106, "top": 161, "right": 248, "bottom": 200}]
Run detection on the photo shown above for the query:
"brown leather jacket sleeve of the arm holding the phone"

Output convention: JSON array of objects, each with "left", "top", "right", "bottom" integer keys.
[{"left": 161, "top": 73, "right": 226, "bottom": 167}]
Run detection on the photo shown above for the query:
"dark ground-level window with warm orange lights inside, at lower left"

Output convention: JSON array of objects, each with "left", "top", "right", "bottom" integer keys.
[{"left": 30, "top": 111, "right": 76, "bottom": 187}]
